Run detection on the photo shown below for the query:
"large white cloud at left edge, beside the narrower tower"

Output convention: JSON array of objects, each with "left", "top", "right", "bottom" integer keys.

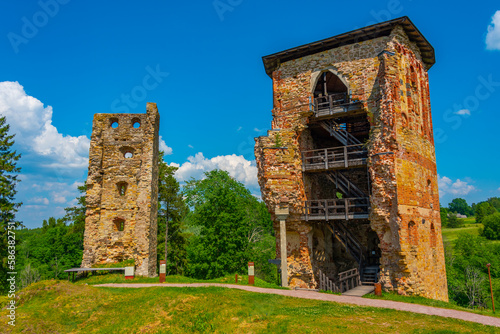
[{"left": 0, "top": 81, "right": 90, "bottom": 169}]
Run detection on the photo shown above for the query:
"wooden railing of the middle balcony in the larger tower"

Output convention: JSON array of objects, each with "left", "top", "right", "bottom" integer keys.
[{"left": 302, "top": 144, "right": 368, "bottom": 171}]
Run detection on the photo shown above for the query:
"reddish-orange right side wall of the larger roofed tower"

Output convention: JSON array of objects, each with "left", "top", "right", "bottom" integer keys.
[{"left": 380, "top": 29, "right": 448, "bottom": 300}]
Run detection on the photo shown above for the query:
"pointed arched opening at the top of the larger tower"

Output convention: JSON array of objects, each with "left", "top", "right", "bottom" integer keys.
[{"left": 314, "top": 71, "right": 349, "bottom": 110}]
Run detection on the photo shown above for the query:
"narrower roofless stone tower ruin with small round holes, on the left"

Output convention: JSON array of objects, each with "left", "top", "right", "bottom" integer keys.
[{"left": 82, "top": 103, "right": 160, "bottom": 276}]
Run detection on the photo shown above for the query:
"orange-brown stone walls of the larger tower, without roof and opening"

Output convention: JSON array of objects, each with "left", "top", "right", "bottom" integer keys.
[{"left": 255, "top": 26, "right": 448, "bottom": 300}]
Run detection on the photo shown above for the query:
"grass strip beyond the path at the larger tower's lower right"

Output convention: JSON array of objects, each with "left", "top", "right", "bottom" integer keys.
[{"left": 363, "top": 292, "right": 500, "bottom": 318}]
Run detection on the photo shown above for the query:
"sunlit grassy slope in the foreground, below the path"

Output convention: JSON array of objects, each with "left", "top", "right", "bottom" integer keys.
[{"left": 0, "top": 280, "right": 498, "bottom": 334}]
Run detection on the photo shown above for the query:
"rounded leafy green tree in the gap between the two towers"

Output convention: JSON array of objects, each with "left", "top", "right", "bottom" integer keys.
[{"left": 184, "top": 170, "right": 274, "bottom": 279}]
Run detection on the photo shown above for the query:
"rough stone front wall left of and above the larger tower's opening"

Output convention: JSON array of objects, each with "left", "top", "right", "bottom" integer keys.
[{"left": 255, "top": 37, "right": 389, "bottom": 288}]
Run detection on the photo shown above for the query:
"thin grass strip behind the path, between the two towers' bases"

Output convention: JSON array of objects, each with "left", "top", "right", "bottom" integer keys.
[{"left": 75, "top": 273, "right": 288, "bottom": 289}]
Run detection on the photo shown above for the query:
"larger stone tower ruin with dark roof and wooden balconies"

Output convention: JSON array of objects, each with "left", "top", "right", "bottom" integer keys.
[{"left": 255, "top": 17, "right": 448, "bottom": 300}]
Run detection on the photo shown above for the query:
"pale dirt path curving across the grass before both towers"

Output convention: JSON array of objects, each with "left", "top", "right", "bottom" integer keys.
[{"left": 94, "top": 283, "right": 500, "bottom": 327}]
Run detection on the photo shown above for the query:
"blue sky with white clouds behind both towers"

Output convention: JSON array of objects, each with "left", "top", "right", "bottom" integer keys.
[{"left": 0, "top": 0, "right": 500, "bottom": 227}]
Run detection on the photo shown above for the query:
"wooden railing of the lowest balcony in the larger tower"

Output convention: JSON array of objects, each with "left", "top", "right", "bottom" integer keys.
[{"left": 303, "top": 197, "right": 370, "bottom": 221}]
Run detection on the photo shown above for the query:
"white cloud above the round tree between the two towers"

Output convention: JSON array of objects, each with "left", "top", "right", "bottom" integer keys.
[{"left": 170, "top": 152, "right": 258, "bottom": 188}]
